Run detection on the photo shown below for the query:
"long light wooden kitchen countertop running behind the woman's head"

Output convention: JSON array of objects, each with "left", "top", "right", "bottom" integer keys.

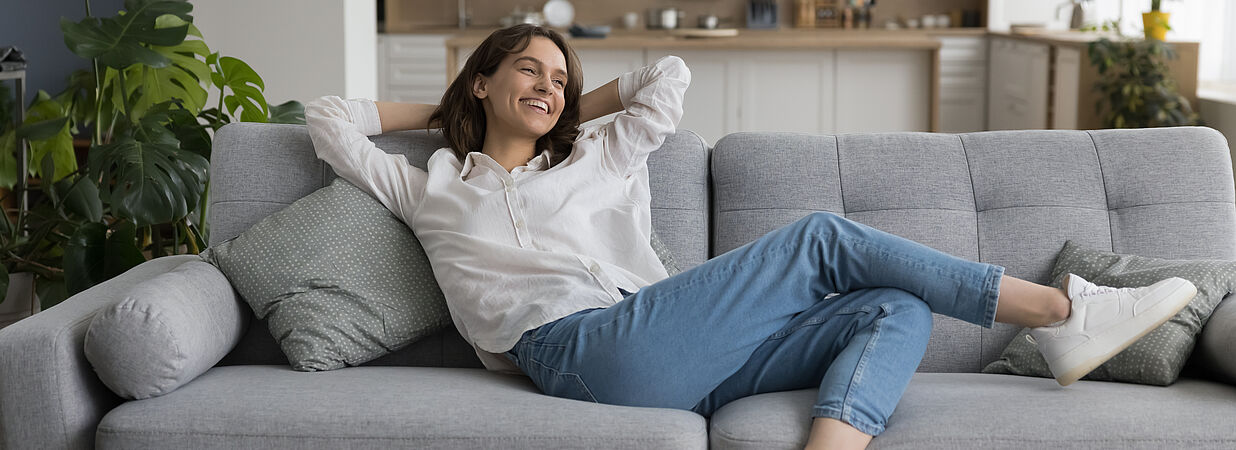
[{"left": 392, "top": 27, "right": 986, "bottom": 49}]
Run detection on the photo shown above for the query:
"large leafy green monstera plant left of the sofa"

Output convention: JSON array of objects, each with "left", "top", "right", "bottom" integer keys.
[{"left": 0, "top": 0, "right": 304, "bottom": 308}]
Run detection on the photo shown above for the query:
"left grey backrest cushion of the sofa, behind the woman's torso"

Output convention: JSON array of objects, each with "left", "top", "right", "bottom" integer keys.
[{"left": 209, "top": 124, "right": 709, "bottom": 367}]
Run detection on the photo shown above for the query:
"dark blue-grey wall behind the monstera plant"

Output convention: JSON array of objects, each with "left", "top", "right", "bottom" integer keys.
[{"left": 0, "top": 0, "right": 124, "bottom": 106}]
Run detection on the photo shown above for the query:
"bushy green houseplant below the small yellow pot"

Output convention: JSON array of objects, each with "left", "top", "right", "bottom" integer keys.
[{"left": 1089, "top": 38, "right": 1200, "bottom": 129}]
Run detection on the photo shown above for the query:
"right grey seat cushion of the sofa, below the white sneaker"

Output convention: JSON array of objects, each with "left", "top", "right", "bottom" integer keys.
[{"left": 709, "top": 373, "right": 1236, "bottom": 450}]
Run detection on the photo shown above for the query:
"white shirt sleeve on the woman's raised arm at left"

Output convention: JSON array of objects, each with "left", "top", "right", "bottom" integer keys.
[{"left": 305, "top": 95, "right": 428, "bottom": 223}]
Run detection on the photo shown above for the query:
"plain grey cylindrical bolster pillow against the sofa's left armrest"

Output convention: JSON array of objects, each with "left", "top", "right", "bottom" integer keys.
[{"left": 84, "top": 261, "right": 252, "bottom": 399}]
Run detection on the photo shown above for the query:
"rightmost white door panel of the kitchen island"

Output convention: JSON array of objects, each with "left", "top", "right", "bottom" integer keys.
[{"left": 836, "top": 49, "right": 932, "bottom": 134}]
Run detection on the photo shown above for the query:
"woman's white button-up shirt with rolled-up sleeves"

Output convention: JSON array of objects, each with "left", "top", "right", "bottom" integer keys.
[{"left": 305, "top": 56, "right": 691, "bottom": 373}]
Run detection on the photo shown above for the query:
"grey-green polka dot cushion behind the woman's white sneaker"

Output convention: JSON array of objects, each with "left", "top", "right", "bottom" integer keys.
[{"left": 983, "top": 241, "right": 1236, "bottom": 386}]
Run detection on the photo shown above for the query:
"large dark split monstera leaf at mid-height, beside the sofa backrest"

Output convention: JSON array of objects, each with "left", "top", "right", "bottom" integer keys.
[{"left": 89, "top": 103, "right": 210, "bottom": 226}]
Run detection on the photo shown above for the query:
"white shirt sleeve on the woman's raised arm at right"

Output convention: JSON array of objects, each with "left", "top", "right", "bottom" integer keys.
[{"left": 602, "top": 56, "right": 691, "bottom": 177}]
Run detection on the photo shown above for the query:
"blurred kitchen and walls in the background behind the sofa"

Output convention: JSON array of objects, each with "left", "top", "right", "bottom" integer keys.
[{"left": 7, "top": 0, "right": 1236, "bottom": 143}]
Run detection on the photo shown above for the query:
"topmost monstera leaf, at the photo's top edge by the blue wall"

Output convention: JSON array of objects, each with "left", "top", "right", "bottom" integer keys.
[{"left": 61, "top": 0, "right": 193, "bottom": 69}]
